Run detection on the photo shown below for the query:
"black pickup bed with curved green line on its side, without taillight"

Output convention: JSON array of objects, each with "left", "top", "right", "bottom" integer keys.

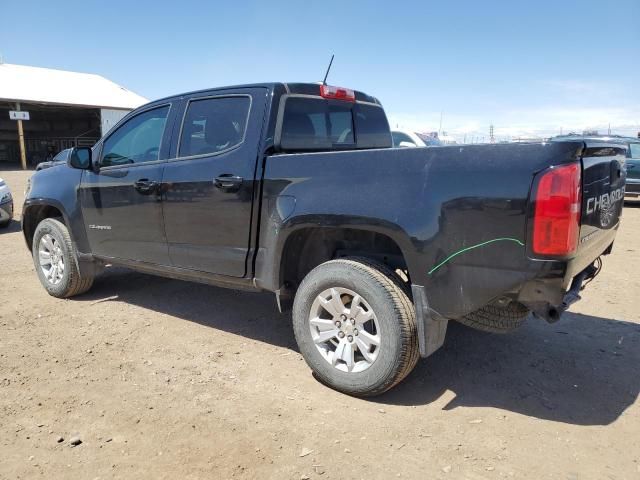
[{"left": 256, "top": 142, "right": 624, "bottom": 319}]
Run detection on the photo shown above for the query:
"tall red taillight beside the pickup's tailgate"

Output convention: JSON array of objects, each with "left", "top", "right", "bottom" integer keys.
[{"left": 532, "top": 163, "right": 580, "bottom": 255}]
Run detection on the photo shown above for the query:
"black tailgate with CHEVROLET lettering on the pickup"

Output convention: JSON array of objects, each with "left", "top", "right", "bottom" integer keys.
[{"left": 578, "top": 141, "right": 627, "bottom": 264}]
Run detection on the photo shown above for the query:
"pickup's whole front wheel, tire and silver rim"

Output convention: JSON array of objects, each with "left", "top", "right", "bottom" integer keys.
[{"left": 32, "top": 218, "right": 94, "bottom": 298}]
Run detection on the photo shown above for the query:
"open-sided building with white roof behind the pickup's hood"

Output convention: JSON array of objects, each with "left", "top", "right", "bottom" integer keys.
[{"left": 0, "top": 63, "right": 148, "bottom": 165}]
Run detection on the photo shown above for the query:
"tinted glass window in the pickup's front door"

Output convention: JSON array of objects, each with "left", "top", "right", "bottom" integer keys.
[{"left": 101, "top": 106, "right": 169, "bottom": 167}]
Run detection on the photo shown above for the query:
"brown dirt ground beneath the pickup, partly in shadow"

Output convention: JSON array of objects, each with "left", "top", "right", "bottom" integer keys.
[{"left": 0, "top": 166, "right": 640, "bottom": 480}]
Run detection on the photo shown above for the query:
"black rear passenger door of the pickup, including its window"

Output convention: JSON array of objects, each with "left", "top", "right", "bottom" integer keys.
[{"left": 163, "top": 88, "right": 268, "bottom": 277}]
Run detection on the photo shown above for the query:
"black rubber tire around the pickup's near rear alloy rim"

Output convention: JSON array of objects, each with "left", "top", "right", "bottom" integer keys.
[{"left": 293, "top": 258, "right": 419, "bottom": 397}]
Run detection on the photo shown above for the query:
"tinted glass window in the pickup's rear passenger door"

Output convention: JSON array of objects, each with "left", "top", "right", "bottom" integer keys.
[{"left": 178, "top": 96, "right": 251, "bottom": 157}]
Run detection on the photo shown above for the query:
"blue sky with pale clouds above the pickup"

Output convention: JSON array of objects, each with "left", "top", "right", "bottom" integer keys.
[{"left": 0, "top": 0, "right": 640, "bottom": 140}]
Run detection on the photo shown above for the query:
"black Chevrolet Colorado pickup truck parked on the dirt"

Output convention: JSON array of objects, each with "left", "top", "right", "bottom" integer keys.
[{"left": 22, "top": 83, "right": 627, "bottom": 396}]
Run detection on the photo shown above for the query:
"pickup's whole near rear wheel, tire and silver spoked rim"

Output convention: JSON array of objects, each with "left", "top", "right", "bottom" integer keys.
[{"left": 293, "top": 258, "right": 419, "bottom": 396}]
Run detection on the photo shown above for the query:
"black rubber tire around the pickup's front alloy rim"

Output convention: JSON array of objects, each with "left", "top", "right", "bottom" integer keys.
[{"left": 31, "top": 218, "right": 94, "bottom": 298}]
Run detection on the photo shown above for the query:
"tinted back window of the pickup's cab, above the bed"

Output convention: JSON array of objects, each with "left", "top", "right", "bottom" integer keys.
[{"left": 280, "top": 97, "right": 391, "bottom": 150}]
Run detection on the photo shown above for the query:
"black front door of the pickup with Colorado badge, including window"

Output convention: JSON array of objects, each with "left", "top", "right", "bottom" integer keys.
[{"left": 79, "top": 105, "right": 170, "bottom": 265}]
